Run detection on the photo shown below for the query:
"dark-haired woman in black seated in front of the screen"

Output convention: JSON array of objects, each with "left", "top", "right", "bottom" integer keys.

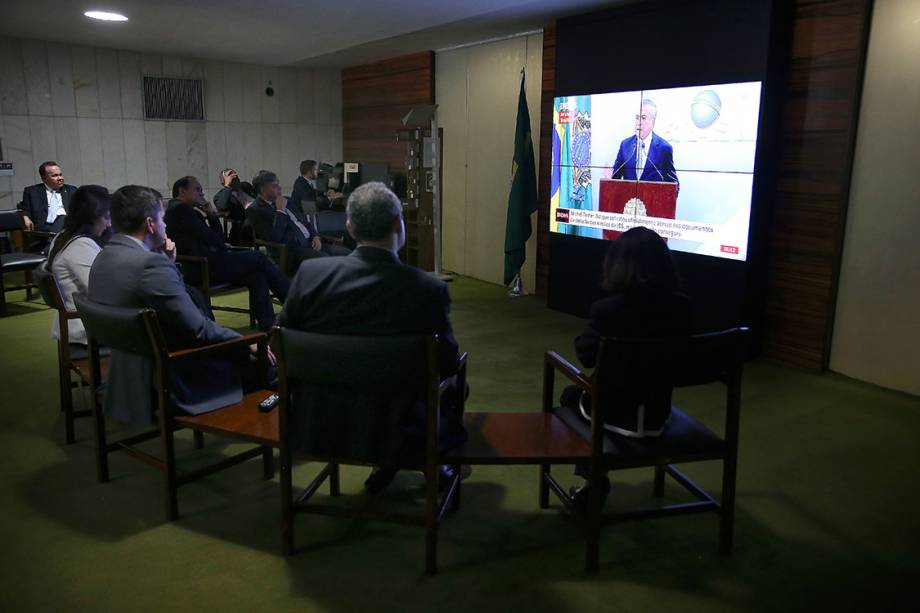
[{"left": 562, "top": 226, "right": 693, "bottom": 504}]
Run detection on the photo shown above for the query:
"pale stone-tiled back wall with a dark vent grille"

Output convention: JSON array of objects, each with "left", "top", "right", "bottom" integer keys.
[{"left": 0, "top": 37, "right": 342, "bottom": 209}]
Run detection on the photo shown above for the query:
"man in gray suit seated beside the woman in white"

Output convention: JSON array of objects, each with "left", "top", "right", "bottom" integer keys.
[{"left": 87, "top": 185, "right": 262, "bottom": 423}]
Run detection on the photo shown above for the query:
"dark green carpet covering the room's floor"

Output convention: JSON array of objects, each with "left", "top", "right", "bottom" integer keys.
[{"left": 0, "top": 279, "right": 920, "bottom": 611}]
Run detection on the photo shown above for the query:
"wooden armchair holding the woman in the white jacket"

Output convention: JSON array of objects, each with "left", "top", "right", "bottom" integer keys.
[{"left": 33, "top": 266, "right": 109, "bottom": 445}]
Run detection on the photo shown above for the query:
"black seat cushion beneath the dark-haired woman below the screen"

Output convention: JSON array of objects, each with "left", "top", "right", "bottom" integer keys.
[{"left": 553, "top": 406, "right": 726, "bottom": 468}]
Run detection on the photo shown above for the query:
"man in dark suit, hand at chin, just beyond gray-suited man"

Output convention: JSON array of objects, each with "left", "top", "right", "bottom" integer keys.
[{"left": 166, "top": 177, "right": 289, "bottom": 331}]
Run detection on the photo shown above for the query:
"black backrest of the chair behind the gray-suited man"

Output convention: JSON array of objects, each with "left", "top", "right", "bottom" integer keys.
[{"left": 73, "top": 294, "right": 156, "bottom": 359}]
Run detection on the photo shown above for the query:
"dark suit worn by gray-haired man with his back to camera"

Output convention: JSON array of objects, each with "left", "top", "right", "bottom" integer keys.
[{"left": 279, "top": 246, "right": 465, "bottom": 466}]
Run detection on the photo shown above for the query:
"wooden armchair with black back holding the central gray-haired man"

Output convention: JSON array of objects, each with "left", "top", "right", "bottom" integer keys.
[{"left": 273, "top": 328, "right": 466, "bottom": 574}]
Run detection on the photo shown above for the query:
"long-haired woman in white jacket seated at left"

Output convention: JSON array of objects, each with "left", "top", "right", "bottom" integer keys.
[{"left": 45, "top": 185, "right": 112, "bottom": 345}]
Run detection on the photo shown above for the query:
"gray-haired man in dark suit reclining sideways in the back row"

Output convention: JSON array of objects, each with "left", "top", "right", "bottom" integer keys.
[{"left": 248, "top": 167, "right": 349, "bottom": 274}]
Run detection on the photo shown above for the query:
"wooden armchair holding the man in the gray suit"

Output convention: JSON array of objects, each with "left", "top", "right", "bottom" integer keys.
[{"left": 74, "top": 295, "right": 278, "bottom": 521}]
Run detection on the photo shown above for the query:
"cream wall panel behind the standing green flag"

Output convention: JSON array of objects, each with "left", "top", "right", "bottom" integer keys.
[{"left": 435, "top": 34, "right": 543, "bottom": 293}]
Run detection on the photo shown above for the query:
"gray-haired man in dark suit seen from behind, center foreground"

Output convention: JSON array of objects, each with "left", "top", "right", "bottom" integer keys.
[{"left": 279, "top": 183, "right": 466, "bottom": 492}]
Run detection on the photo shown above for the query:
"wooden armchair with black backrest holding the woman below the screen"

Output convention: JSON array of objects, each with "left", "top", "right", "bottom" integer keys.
[{"left": 540, "top": 328, "right": 748, "bottom": 571}]
